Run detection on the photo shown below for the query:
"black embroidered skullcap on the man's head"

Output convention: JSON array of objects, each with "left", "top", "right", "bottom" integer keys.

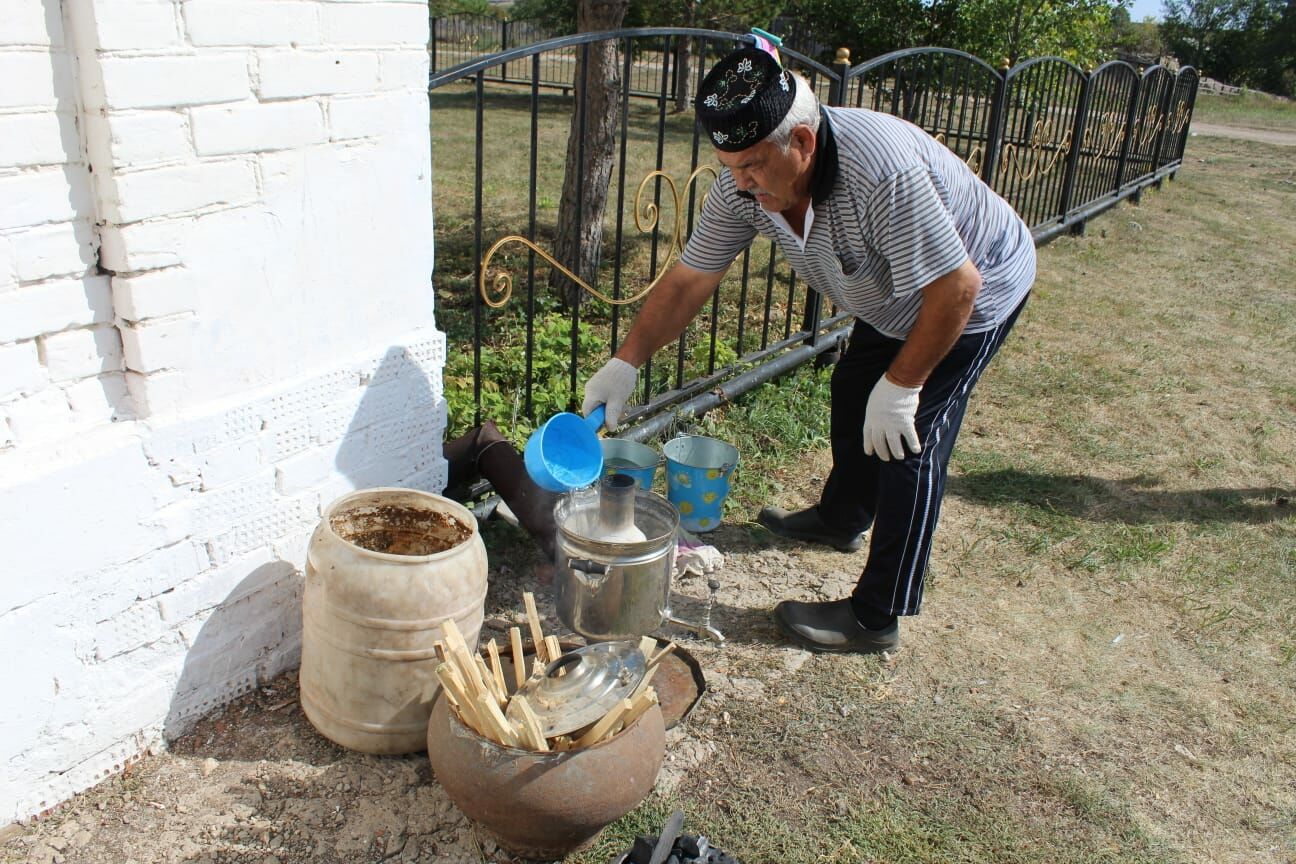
[{"left": 696, "top": 47, "right": 797, "bottom": 153}]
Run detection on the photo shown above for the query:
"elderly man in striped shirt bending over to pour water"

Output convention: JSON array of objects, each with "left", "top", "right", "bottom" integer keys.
[{"left": 584, "top": 48, "right": 1036, "bottom": 653}]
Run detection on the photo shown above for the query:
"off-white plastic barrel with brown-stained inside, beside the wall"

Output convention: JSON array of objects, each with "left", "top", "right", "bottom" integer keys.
[{"left": 299, "top": 488, "right": 486, "bottom": 754}]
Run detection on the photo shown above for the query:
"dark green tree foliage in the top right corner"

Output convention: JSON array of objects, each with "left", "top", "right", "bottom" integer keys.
[{"left": 1163, "top": 0, "right": 1296, "bottom": 93}]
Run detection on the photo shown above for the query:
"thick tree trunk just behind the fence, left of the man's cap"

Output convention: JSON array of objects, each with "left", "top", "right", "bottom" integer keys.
[{"left": 550, "top": 0, "right": 630, "bottom": 307}]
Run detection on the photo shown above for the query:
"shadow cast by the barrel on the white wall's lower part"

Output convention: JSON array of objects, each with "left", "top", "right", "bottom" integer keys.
[{"left": 163, "top": 561, "right": 302, "bottom": 740}]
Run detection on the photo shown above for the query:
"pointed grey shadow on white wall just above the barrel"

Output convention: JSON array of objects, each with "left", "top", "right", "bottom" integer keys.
[{"left": 334, "top": 346, "right": 446, "bottom": 492}]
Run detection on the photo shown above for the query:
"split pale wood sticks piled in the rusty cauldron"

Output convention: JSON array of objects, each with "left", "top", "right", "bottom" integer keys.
[{"left": 437, "top": 592, "right": 675, "bottom": 753}]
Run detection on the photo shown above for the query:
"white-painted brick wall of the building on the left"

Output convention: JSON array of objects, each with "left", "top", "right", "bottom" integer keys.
[{"left": 0, "top": 0, "right": 446, "bottom": 824}]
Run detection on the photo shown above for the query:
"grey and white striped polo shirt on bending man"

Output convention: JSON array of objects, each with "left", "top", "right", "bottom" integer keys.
[{"left": 680, "top": 108, "right": 1036, "bottom": 338}]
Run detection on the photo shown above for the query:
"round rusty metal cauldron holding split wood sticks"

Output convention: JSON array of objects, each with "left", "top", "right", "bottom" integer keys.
[{"left": 428, "top": 694, "right": 666, "bottom": 861}]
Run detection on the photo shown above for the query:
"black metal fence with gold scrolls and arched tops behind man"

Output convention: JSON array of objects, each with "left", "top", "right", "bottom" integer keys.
[{"left": 429, "top": 27, "right": 1198, "bottom": 439}]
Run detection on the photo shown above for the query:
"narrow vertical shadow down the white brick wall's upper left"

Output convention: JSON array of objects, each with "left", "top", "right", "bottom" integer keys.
[{"left": 46, "top": 0, "right": 137, "bottom": 421}]
